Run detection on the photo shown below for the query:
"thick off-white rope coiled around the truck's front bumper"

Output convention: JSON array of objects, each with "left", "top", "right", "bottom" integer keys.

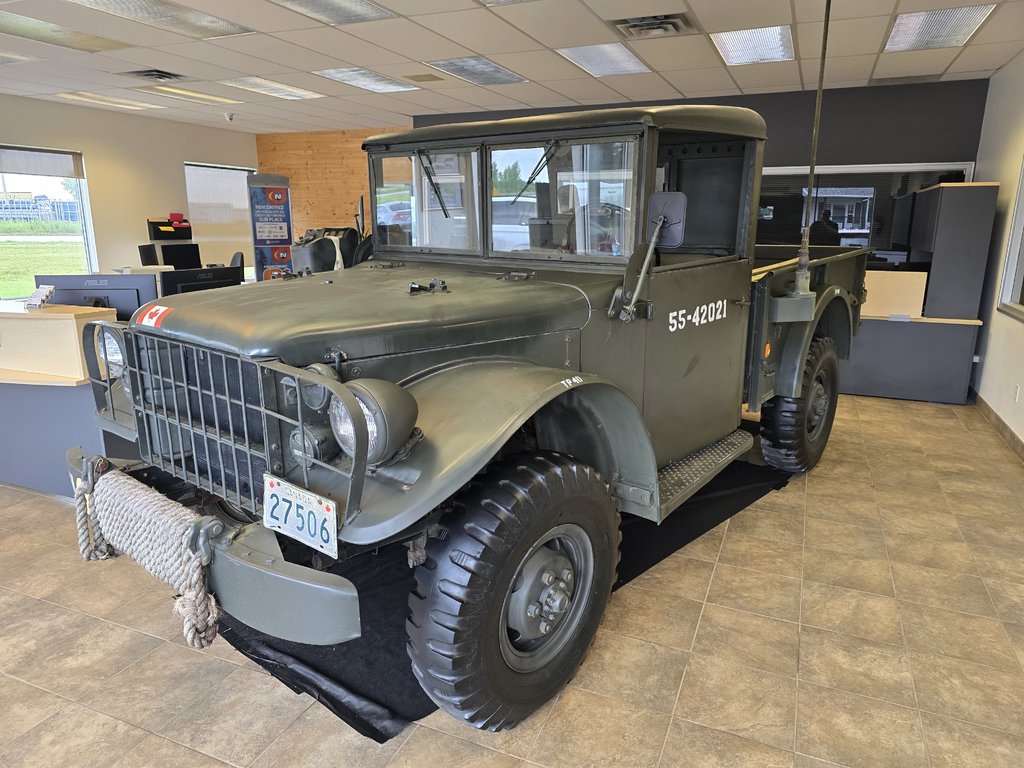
[{"left": 75, "top": 461, "right": 217, "bottom": 648}]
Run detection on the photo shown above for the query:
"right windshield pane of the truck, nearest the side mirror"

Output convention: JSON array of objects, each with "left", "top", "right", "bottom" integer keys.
[{"left": 490, "top": 139, "right": 637, "bottom": 260}]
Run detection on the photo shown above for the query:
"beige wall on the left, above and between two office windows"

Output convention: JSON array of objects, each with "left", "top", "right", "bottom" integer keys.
[{"left": 0, "top": 95, "right": 256, "bottom": 270}]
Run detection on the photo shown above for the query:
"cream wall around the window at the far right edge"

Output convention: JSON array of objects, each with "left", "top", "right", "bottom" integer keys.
[{"left": 970, "top": 55, "right": 1024, "bottom": 437}]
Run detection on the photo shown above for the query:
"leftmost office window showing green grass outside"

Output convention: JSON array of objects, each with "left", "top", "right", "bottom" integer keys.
[{"left": 0, "top": 145, "right": 95, "bottom": 299}]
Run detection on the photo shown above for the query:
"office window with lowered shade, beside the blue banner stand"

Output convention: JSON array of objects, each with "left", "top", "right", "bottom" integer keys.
[{"left": 185, "top": 163, "right": 253, "bottom": 266}]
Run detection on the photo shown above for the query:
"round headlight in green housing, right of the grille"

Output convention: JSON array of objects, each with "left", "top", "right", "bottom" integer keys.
[{"left": 330, "top": 379, "right": 419, "bottom": 465}]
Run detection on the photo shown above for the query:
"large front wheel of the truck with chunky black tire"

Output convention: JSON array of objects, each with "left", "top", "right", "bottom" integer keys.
[{"left": 407, "top": 453, "right": 620, "bottom": 731}]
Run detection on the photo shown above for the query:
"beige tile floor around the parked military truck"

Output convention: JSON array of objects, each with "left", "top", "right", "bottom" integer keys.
[{"left": 0, "top": 397, "right": 1024, "bottom": 768}]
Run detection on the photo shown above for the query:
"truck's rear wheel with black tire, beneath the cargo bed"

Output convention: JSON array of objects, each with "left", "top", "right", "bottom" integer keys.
[{"left": 761, "top": 336, "right": 839, "bottom": 472}]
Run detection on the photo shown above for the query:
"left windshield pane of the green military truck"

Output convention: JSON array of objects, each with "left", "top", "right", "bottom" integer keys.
[{"left": 374, "top": 150, "right": 480, "bottom": 253}]
